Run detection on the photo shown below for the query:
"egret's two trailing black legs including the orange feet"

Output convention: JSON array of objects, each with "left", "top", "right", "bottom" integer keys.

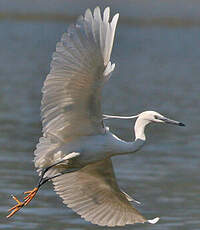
[{"left": 7, "top": 152, "right": 80, "bottom": 218}]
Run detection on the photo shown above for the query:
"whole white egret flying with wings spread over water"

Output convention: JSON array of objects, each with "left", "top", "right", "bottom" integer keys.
[{"left": 7, "top": 7, "right": 184, "bottom": 226}]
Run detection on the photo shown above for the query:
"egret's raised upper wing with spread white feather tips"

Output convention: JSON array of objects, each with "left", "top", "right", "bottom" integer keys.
[{"left": 41, "top": 7, "right": 119, "bottom": 140}]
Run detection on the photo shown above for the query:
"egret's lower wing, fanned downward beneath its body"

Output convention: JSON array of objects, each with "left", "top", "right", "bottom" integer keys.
[{"left": 53, "top": 159, "right": 148, "bottom": 226}]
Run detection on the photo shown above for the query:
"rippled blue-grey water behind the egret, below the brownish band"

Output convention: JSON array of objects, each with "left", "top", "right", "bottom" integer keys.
[{"left": 0, "top": 2, "right": 200, "bottom": 230}]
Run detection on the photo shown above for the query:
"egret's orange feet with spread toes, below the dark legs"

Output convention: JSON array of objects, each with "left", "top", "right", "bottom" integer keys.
[{"left": 7, "top": 188, "right": 38, "bottom": 218}]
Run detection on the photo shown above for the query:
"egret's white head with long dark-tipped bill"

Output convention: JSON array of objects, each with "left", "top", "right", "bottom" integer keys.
[{"left": 139, "top": 111, "right": 185, "bottom": 126}]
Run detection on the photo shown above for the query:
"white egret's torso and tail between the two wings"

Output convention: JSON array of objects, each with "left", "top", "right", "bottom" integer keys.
[{"left": 36, "top": 129, "right": 144, "bottom": 168}]
